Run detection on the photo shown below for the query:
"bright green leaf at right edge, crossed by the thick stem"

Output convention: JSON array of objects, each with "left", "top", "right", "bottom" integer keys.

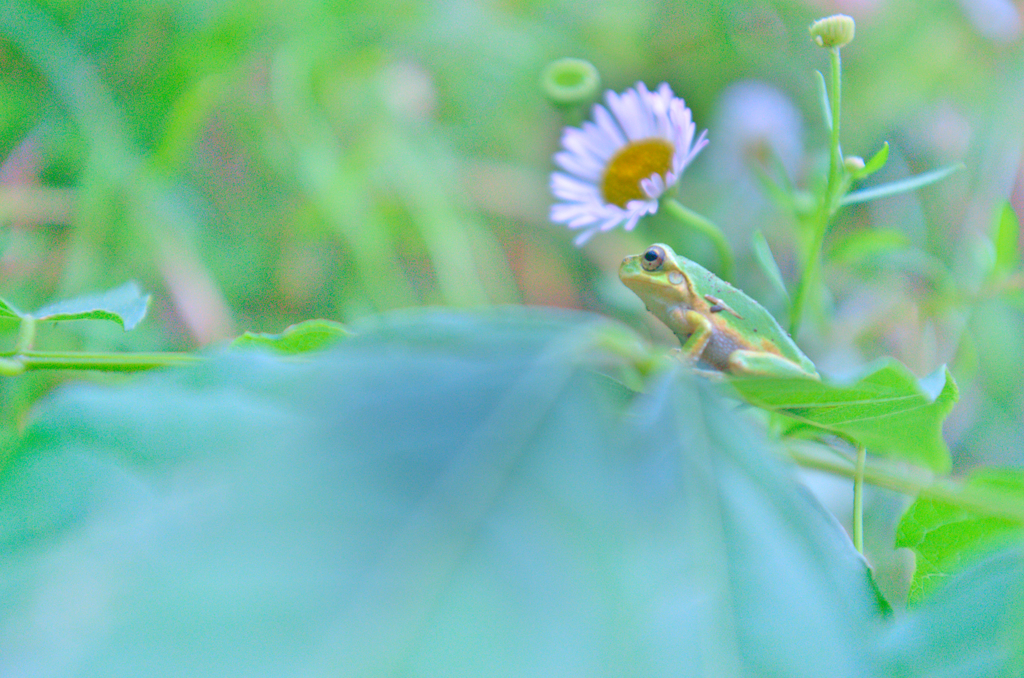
[{"left": 896, "top": 469, "right": 1024, "bottom": 601}]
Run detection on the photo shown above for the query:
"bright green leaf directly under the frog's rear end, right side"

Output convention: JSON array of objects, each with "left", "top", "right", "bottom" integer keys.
[{"left": 729, "top": 359, "right": 958, "bottom": 473}]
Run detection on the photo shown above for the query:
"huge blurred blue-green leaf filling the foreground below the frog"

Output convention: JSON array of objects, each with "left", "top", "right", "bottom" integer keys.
[{"left": 0, "top": 309, "right": 881, "bottom": 678}]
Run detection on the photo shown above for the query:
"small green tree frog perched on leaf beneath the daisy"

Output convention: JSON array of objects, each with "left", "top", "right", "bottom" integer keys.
[{"left": 618, "top": 244, "right": 819, "bottom": 379}]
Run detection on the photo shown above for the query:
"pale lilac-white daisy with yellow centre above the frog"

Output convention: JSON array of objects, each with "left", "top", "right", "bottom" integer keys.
[{"left": 551, "top": 82, "right": 708, "bottom": 246}]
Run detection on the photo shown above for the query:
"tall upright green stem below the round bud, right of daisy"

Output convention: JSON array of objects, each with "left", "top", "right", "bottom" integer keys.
[{"left": 790, "top": 47, "right": 844, "bottom": 338}]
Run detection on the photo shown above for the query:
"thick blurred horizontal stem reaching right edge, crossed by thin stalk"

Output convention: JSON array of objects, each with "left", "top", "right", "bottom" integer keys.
[{"left": 785, "top": 446, "right": 1024, "bottom": 523}]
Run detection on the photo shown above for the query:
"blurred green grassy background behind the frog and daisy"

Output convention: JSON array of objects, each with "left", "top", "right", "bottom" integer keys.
[{"left": 0, "top": 0, "right": 1024, "bottom": 675}]
